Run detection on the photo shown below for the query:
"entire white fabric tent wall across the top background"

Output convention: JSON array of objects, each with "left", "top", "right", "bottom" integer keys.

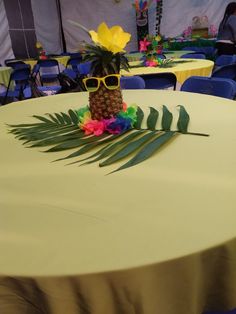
[{"left": 0, "top": 0, "right": 231, "bottom": 59}]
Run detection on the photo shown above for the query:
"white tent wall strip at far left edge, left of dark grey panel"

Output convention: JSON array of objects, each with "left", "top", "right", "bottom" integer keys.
[{"left": 0, "top": 0, "right": 14, "bottom": 65}]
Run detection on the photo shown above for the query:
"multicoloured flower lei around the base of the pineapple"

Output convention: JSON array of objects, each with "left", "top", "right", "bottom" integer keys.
[{"left": 77, "top": 103, "right": 137, "bottom": 136}]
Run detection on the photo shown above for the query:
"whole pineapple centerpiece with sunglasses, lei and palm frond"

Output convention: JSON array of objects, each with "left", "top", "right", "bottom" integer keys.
[{"left": 10, "top": 23, "right": 206, "bottom": 172}]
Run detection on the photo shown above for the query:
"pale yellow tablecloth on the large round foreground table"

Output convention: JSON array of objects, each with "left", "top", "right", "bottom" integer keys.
[{"left": 0, "top": 90, "right": 236, "bottom": 314}]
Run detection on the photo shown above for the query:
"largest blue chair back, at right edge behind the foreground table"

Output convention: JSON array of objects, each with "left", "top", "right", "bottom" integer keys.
[{"left": 180, "top": 76, "right": 236, "bottom": 99}]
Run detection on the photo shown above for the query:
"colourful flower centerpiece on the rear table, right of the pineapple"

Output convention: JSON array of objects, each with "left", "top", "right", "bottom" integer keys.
[{"left": 139, "top": 35, "right": 168, "bottom": 67}]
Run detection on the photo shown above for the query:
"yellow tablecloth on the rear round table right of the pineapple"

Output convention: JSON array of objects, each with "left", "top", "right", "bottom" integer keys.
[{"left": 121, "top": 59, "right": 214, "bottom": 84}]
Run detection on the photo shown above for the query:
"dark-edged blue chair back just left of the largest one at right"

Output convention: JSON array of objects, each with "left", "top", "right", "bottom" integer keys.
[{"left": 140, "top": 72, "right": 177, "bottom": 90}]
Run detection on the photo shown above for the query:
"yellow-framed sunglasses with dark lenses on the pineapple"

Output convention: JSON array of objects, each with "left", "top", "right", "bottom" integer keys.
[{"left": 83, "top": 74, "right": 120, "bottom": 92}]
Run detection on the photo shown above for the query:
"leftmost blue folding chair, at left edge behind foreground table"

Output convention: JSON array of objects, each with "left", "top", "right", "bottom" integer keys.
[{"left": 0, "top": 65, "right": 30, "bottom": 105}]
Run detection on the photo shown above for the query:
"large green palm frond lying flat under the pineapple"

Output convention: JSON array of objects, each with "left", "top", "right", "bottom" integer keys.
[{"left": 7, "top": 105, "right": 203, "bottom": 172}]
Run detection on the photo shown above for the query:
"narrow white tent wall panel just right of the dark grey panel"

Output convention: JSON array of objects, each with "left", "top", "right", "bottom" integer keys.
[{"left": 31, "top": 0, "right": 62, "bottom": 54}]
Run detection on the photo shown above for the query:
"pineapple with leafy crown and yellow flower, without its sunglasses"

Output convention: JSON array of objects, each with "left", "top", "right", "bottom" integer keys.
[{"left": 84, "top": 23, "right": 130, "bottom": 120}]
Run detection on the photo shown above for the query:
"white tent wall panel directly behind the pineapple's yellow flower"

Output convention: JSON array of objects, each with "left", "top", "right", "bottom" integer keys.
[{"left": 61, "top": 0, "right": 137, "bottom": 51}]
